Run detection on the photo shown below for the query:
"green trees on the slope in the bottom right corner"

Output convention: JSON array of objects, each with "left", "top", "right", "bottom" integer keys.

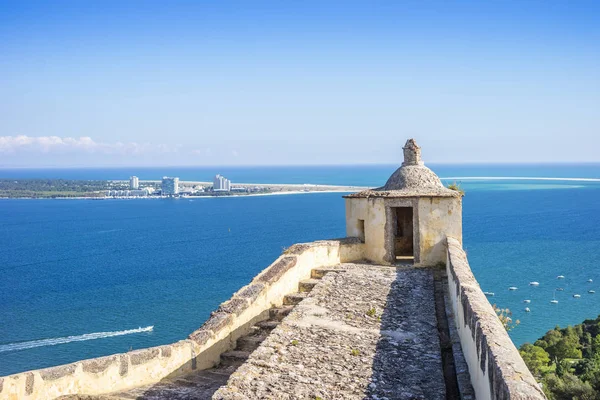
[{"left": 519, "top": 316, "right": 600, "bottom": 400}]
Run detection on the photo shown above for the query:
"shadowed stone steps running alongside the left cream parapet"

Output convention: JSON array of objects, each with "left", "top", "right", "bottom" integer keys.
[{"left": 104, "top": 267, "right": 336, "bottom": 400}]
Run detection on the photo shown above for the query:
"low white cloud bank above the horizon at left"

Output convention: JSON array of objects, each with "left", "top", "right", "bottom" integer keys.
[{"left": 0, "top": 135, "right": 180, "bottom": 155}]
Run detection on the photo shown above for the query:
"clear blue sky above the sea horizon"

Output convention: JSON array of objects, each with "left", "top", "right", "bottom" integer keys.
[{"left": 0, "top": 0, "right": 600, "bottom": 167}]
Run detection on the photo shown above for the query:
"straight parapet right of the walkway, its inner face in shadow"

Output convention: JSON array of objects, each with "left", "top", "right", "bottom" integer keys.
[{"left": 446, "top": 237, "right": 546, "bottom": 400}]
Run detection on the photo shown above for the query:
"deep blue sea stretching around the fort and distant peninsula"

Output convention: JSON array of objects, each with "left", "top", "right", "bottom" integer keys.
[{"left": 0, "top": 165, "right": 600, "bottom": 376}]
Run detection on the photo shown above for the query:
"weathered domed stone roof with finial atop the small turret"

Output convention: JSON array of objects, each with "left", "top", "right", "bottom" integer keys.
[{"left": 346, "top": 139, "right": 460, "bottom": 197}]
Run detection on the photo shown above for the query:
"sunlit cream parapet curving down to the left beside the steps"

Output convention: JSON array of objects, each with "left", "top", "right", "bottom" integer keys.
[{"left": 0, "top": 238, "right": 364, "bottom": 400}]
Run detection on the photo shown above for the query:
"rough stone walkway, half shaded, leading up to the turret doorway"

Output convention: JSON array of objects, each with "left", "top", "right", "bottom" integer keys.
[{"left": 213, "top": 264, "right": 446, "bottom": 400}]
